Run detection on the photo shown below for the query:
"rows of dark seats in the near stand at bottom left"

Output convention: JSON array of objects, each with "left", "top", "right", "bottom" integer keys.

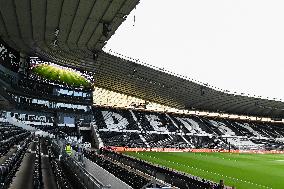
[{"left": 0, "top": 119, "right": 84, "bottom": 189}]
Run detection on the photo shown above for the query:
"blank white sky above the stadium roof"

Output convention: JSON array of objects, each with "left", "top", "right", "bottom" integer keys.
[{"left": 106, "top": 0, "right": 284, "bottom": 99}]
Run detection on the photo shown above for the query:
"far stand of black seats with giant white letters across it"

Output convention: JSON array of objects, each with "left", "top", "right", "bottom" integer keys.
[{"left": 93, "top": 107, "right": 283, "bottom": 150}]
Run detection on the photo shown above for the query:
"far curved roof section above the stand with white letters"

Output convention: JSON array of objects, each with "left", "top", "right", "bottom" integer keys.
[{"left": 95, "top": 52, "right": 284, "bottom": 118}]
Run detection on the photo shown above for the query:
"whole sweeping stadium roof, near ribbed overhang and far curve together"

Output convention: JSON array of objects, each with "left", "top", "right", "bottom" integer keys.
[{"left": 0, "top": 0, "right": 284, "bottom": 118}]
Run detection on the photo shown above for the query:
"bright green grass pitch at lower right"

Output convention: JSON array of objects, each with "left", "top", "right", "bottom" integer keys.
[{"left": 125, "top": 152, "right": 284, "bottom": 189}]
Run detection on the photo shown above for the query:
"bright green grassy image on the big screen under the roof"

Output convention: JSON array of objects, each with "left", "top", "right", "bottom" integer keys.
[{"left": 32, "top": 64, "right": 91, "bottom": 88}]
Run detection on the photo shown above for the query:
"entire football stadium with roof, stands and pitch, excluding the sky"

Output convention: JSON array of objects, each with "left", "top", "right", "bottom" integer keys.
[{"left": 0, "top": 0, "right": 284, "bottom": 189}]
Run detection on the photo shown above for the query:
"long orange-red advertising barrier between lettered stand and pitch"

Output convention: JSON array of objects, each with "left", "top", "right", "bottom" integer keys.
[{"left": 108, "top": 147, "right": 284, "bottom": 154}]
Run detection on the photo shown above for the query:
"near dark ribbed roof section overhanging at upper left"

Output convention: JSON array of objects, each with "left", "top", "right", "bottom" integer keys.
[{"left": 0, "top": 0, "right": 139, "bottom": 65}]
